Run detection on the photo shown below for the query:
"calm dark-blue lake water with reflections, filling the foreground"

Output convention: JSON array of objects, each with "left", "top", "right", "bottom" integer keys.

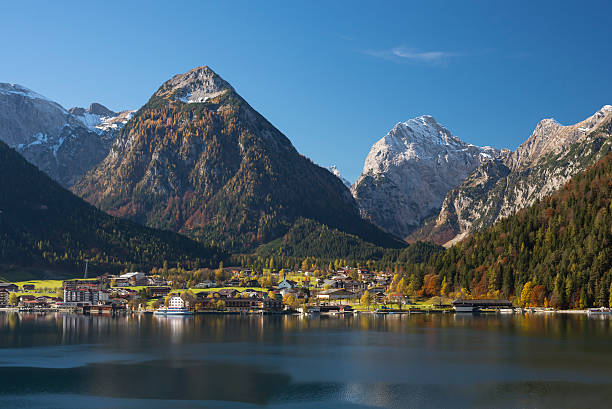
[{"left": 0, "top": 313, "right": 612, "bottom": 409}]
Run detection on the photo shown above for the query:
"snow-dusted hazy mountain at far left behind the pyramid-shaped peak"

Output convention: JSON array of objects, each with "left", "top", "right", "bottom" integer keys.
[{"left": 0, "top": 83, "right": 133, "bottom": 187}]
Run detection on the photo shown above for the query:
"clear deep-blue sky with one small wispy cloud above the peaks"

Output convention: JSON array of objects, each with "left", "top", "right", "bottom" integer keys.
[{"left": 0, "top": 1, "right": 612, "bottom": 181}]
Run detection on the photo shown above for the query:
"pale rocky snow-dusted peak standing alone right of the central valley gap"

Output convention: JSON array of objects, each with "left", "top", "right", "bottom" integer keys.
[{"left": 351, "top": 116, "right": 500, "bottom": 237}]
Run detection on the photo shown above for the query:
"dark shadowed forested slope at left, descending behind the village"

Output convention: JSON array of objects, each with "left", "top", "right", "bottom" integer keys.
[{"left": 0, "top": 142, "right": 225, "bottom": 272}]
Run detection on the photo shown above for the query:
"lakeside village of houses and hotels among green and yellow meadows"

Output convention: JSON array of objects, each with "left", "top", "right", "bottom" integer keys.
[{"left": 0, "top": 267, "right": 464, "bottom": 315}]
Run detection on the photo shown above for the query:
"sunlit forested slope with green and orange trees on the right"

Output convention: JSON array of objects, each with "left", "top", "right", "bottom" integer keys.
[{"left": 420, "top": 138, "right": 612, "bottom": 308}]
